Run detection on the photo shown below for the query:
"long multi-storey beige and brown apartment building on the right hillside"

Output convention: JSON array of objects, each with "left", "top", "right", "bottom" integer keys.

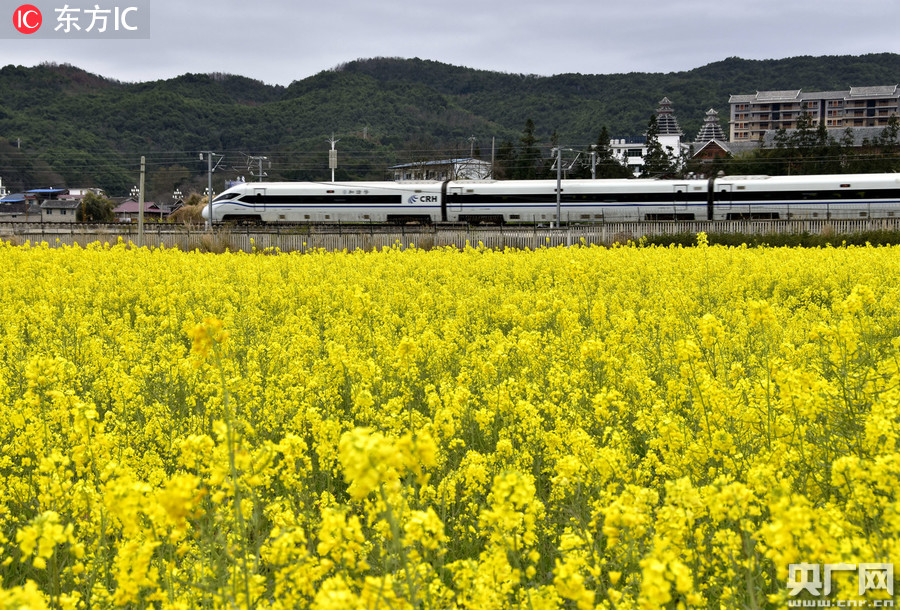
[{"left": 728, "top": 85, "right": 900, "bottom": 142}]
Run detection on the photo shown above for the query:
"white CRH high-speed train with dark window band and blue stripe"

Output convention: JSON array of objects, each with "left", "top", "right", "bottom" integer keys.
[{"left": 203, "top": 174, "right": 900, "bottom": 224}]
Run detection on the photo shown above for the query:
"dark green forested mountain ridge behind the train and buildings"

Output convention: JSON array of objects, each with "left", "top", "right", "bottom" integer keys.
[{"left": 0, "top": 53, "right": 900, "bottom": 196}]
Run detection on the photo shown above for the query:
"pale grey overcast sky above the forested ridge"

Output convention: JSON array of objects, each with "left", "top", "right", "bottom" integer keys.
[{"left": 0, "top": 0, "right": 900, "bottom": 85}]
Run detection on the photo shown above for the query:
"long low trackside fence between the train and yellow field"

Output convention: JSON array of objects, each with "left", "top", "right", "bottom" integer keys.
[{"left": 0, "top": 218, "right": 900, "bottom": 252}]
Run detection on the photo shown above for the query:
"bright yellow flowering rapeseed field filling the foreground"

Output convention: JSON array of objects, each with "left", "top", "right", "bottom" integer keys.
[{"left": 0, "top": 234, "right": 900, "bottom": 610}]
